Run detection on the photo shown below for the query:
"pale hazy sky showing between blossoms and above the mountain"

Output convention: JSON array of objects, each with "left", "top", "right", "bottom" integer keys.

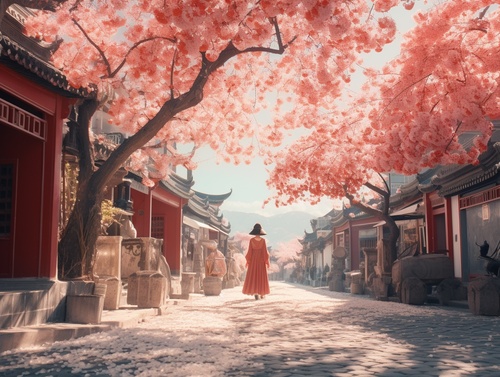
[{"left": 182, "top": 1, "right": 433, "bottom": 217}]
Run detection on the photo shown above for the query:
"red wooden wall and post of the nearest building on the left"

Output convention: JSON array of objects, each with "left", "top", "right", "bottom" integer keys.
[{"left": 0, "top": 66, "right": 69, "bottom": 278}]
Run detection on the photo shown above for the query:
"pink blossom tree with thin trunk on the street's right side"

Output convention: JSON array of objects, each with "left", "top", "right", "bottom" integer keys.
[{"left": 268, "top": 0, "right": 500, "bottom": 268}]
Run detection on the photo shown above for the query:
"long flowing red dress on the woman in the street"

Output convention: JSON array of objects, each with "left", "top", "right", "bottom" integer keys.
[{"left": 243, "top": 237, "right": 270, "bottom": 296}]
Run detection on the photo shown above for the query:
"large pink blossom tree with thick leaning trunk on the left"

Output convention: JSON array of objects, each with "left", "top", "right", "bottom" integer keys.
[{"left": 23, "top": 0, "right": 402, "bottom": 278}]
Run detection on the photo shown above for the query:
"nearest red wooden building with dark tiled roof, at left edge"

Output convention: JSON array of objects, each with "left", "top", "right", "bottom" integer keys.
[{"left": 0, "top": 6, "right": 83, "bottom": 278}]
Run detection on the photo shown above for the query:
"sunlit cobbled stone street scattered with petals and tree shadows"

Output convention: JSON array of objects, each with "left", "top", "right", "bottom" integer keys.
[{"left": 0, "top": 282, "right": 500, "bottom": 377}]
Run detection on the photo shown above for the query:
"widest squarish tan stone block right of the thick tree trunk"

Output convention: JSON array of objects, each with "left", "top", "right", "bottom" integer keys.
[{"left": 127, "top": 271, "right": 168, "bottom": 308}]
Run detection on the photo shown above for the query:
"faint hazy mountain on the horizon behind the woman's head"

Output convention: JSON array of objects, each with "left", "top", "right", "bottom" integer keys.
[{"left": 222, "top": 211, "right": 316, "bottom": 246}]
